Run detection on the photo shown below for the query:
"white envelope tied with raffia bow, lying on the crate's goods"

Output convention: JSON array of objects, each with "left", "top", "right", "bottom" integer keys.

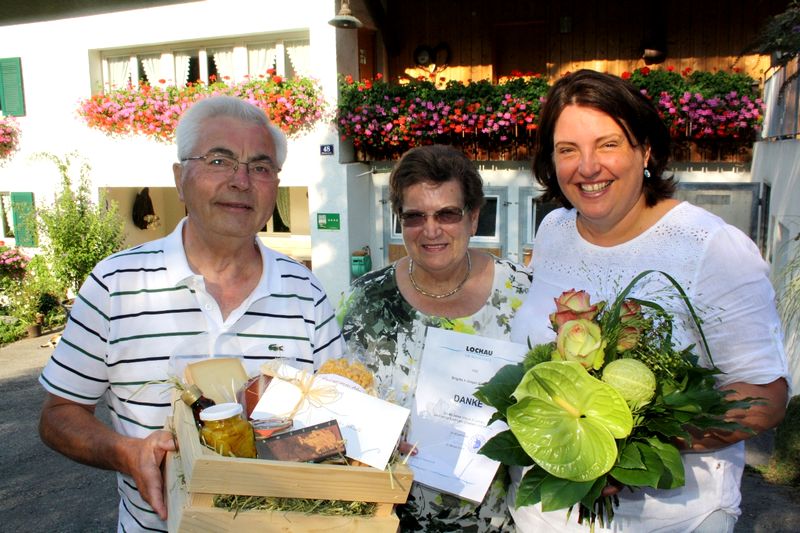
[{"left": 250, "top": 365, "right": 409, "bottom": 470}]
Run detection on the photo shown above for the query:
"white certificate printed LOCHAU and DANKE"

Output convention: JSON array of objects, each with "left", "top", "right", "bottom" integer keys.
[{"left": 408, "top": 328, "right": 528, "bottom": 502}]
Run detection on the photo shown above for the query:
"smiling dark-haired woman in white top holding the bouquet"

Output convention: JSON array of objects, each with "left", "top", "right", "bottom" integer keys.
[{"left": 509, "top": 70, "right": 788, "bottom": 532}]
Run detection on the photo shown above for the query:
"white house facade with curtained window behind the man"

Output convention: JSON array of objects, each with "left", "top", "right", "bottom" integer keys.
[{"left": 0, "top": 0, "right": 376, "bottom": 300}]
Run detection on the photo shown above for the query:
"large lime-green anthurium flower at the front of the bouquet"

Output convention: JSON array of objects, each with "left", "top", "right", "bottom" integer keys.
[{"left": 507, "top": 361, "right": 633, "bottom": 482}]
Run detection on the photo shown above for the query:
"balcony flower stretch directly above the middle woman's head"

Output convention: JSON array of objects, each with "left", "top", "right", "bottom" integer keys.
[{"left": 336, "top": 73, "right": 548, "bottom": 160}]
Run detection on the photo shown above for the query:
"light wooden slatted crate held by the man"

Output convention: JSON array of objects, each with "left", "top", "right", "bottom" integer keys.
[{"left": 165, "top": 401, "right": 413, "bottom": 533}]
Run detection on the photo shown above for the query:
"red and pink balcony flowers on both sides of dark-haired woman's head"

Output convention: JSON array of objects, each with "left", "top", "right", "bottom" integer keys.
[{"left": 336, "top": 67, "right": 763, "bottom": 162}]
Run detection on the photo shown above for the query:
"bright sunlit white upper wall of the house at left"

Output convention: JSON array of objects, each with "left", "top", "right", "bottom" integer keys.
[{"left": 0, "top": 0, "right": 337, "bottom": 190}]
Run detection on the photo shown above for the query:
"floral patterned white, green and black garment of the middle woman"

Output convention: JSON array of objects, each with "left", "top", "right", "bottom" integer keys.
[{"left": 339, "top": 258, "right": 531, "bottom": 532}]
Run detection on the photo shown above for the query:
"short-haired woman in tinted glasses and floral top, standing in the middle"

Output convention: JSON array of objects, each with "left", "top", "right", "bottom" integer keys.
[{"left": 340, "top": 145, "right": 531, "bottom": 531}]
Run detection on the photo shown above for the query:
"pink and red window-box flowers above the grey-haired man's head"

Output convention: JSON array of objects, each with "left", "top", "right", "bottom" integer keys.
[{"left": 78, "top": 69, "right": 325, "bottom": 142}]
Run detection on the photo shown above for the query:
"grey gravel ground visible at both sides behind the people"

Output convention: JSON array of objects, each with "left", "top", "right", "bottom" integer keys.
[{"left": 0, "top": 326, "right": 800, "bottom": 533}]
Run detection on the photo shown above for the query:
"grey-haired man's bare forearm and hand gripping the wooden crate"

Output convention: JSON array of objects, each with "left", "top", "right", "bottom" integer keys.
[{"left": 39, "top": 394, "right": 177, "bottom": 520}]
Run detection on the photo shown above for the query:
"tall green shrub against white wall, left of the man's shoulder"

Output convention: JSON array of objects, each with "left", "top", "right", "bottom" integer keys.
[{"left": 38, "top": 152, "right": 125, "bottom": 292}]
